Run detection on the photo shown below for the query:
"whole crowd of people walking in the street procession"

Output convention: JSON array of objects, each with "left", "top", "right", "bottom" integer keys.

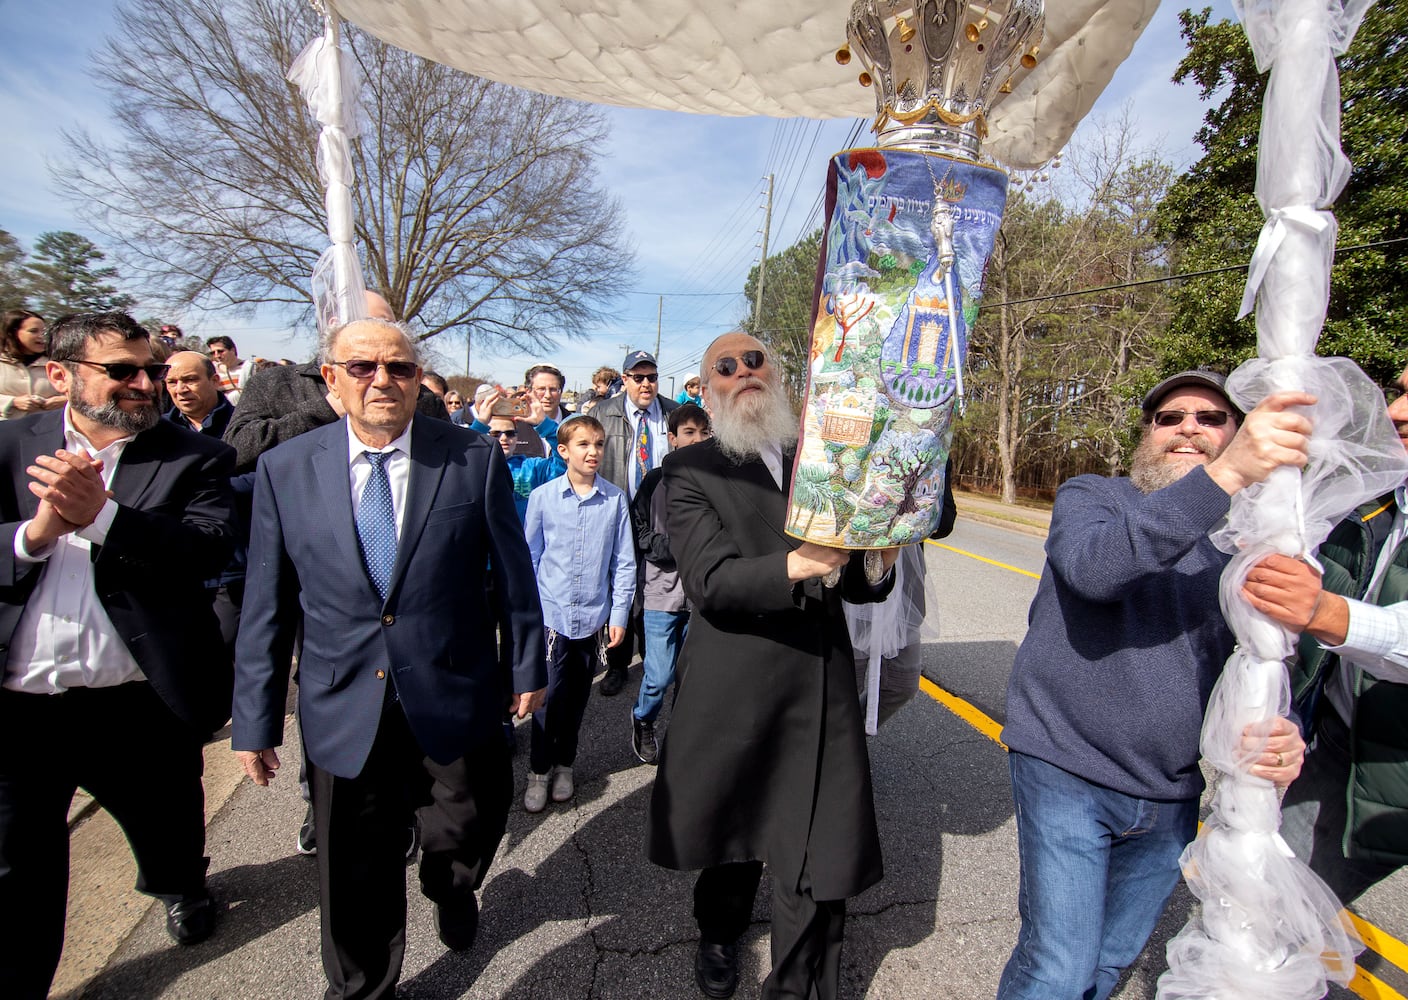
[{"left": 0, "top": 305, "right": 1408, "bottom": 1000}]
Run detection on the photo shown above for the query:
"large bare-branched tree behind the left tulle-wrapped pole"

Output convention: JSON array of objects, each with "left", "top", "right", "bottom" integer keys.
[{"left": 56, "top": 0, "right": 634, "bottom": 351}]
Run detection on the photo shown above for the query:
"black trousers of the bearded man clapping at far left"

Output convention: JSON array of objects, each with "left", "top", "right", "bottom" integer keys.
[{"left": 0, "top": 682, "right": 208, "bottom": 1000}]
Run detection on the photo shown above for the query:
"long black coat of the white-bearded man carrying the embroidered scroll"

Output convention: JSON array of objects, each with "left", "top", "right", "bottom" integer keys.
[{"left": 644, "top": 439, "right": 894, "bottom": 900}]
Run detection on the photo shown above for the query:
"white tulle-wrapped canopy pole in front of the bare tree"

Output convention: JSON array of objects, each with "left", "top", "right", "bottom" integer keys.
[{"left": 289, "top": 0, "right": 366, "bottom": 337}]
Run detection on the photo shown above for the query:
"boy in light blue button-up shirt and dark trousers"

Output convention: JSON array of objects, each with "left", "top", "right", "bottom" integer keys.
[{"left": 524, "top": 415, "right": 635, "bottom": 813}]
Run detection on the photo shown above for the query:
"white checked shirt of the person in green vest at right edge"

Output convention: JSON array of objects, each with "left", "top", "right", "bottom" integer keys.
[{"left": 1325, "top": 486, "right": 1408, "bottom": 723}]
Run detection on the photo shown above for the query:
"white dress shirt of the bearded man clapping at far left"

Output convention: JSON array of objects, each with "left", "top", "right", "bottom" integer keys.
[{"left": 4, "top": 407, "right": 146, "bottom": 694}]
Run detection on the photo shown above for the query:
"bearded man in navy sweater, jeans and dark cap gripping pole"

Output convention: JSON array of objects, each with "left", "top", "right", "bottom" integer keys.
[{"left": 997, "top": 372, "right": 1315, "bottom": 1000}]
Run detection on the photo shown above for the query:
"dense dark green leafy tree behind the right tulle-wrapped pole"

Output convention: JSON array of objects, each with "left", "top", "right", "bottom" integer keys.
[{"left": 1159, "top": 3, "right": 1408, "bottom": 377}]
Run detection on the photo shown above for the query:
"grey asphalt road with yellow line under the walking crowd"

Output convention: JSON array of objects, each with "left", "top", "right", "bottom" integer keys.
[{"left": 54, "top": 517, "right": 1408, "bottom": 1000}]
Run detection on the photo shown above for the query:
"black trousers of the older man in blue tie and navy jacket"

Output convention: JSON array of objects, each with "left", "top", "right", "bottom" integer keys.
[{"left": 308, "top": 700, "right": 513, "bottom": 1000}]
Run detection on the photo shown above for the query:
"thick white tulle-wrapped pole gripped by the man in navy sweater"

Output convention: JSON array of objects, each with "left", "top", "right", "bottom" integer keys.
[{"left": 1159, "top": 0, "right": 1408, "bottom": 1000}]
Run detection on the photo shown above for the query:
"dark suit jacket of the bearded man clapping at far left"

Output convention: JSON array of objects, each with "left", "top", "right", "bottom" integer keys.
[{"left": 0, "top": 410, "right": 235, "bottom": 732}]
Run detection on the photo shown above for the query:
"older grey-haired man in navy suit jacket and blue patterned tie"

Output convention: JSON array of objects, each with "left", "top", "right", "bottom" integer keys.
[{"left": 234, "top": 320, "right": 546, "bottom": 1000}]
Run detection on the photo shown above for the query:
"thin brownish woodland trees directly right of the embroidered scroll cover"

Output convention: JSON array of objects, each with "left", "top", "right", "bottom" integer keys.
[{"left": 953, "top": 115, "right": 1173, "bottom": 503}]
